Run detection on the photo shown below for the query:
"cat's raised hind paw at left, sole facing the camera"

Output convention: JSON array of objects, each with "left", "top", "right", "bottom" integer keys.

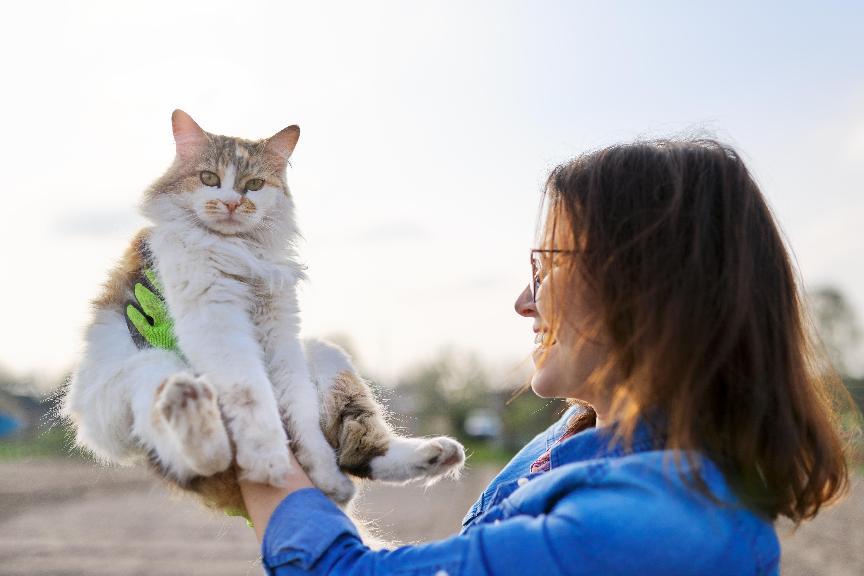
[{"left": 153, "top": 372, "right": 232, "bottom": 476}]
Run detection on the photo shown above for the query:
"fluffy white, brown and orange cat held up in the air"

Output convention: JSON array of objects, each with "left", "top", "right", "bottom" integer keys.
[{"left": 63, "top": 110, "right": 465, "bottom": 510}]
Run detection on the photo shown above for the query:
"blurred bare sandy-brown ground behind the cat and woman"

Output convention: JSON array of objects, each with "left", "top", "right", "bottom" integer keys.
[{"left": 0, "top": 460, "right": 864, "bottom": 576}]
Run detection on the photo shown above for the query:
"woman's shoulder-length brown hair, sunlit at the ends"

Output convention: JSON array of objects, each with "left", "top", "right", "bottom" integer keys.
[{"left": 543, "top": 140, "right": 848, "bottom": 522}]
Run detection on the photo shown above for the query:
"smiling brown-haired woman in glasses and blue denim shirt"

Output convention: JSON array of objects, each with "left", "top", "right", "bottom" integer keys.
[{"left": 236, "top": 140, "right": 847, "bottom": 576}]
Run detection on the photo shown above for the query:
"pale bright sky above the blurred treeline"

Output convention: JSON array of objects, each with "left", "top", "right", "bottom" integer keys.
[{"left": 0, "top": 0, "right": 864, "bottom": 381}]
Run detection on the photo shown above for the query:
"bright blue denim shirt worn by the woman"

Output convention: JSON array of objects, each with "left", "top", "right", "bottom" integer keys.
[{"left": 262, "top": 408, "right": 780, "bottom": 576}]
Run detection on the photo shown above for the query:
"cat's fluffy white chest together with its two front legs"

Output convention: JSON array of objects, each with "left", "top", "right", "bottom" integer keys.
[{"left": 148, "top": 222, "right": 340, "bottom": 492}]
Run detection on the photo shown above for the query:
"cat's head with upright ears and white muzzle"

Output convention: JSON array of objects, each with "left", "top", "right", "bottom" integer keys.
[{"left": 143, "top": 110, "right": 300, "bottom": 235}]
